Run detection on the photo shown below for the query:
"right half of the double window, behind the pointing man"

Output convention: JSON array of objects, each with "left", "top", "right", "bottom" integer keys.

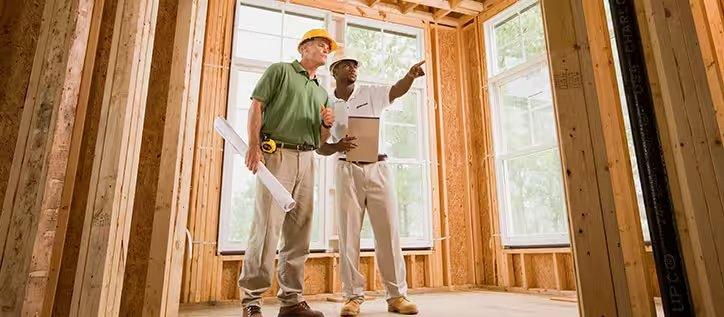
[{"left": 345, "top": 18, "right": 432, "bottom": 249}]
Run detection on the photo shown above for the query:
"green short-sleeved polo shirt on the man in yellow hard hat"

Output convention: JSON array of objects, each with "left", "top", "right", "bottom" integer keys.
[{"left": 252, "top": 60, "right": 329, "bottom": 147}]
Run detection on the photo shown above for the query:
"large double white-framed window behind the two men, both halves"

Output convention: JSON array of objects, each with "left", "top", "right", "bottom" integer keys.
[{"left": 219, "top": 0, "right": 432, "bottom": 252}]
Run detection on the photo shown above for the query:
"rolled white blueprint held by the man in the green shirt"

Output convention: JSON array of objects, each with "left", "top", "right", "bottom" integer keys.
[{"left": 214, "top": 117, "right": 297, "bottom": 212}]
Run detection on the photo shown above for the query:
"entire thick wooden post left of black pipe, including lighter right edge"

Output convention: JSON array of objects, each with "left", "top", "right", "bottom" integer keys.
[{"left": 542, "top": 0, "right": 653, "bottom": 316}]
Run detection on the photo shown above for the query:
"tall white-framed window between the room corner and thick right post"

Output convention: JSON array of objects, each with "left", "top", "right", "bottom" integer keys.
[{"left": 483, "top": 1, "right": 569, "bottom": 246}]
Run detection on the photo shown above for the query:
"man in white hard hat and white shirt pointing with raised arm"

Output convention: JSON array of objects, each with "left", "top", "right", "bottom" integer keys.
[{"left": 317, "top": 50, "right": 425, "bottom": 316}]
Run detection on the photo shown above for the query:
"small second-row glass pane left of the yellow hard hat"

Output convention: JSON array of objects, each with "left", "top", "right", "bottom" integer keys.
[{"left": 234, "top": 30, "right": 282, "bottom": 62}]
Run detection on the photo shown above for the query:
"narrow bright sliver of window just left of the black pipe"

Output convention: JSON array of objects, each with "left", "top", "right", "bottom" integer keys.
[{"left": 603, "top": 0, "right": 651, "bottom": 242}]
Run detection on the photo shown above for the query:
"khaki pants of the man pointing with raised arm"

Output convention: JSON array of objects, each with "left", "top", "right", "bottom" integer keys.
[{"left": 336, "top": 161, "right": 407, "bottom": 299}]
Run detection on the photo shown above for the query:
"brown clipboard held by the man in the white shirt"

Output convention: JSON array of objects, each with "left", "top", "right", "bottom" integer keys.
[{"left": 347, "top": 116, "right": 380, "bottom": 162}]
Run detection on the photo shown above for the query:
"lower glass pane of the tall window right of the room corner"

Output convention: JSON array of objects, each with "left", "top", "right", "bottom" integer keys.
[{"left": 503, "top": 149, "right": 567, "bottom": 236}]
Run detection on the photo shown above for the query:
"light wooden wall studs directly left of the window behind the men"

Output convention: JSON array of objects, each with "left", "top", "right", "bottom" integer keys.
[{"left": 181, "top": 0, "right": 235, "bottom": 302}]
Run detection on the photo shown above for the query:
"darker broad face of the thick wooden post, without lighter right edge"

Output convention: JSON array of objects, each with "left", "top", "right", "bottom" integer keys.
[{"left": 542, "top": 0, "right": 650, "bottom": 316}]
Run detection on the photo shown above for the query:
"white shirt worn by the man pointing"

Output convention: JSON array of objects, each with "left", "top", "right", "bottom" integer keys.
[{"left": 330, "top": 85, "right": 391, "bottom": 157}]
